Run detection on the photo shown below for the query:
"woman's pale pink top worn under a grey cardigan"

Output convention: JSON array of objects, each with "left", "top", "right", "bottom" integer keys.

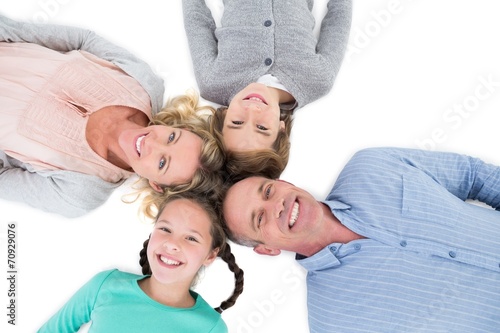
[{"left": 0, "top": 42, "right": 151, "bottom": 182}]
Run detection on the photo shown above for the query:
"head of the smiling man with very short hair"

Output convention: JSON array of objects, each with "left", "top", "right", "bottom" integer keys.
[{"left": 223, "top": 177, "right": 324, "bottom": 255}]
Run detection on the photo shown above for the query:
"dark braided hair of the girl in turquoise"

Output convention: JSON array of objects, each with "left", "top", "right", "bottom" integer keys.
[{"left": 139, "top": 192, "right": 244, "bottom": 313}]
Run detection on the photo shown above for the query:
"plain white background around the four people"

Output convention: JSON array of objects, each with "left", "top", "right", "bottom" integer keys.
[{"left": 0, "top": 0, "right": 500, "bottom": 333}]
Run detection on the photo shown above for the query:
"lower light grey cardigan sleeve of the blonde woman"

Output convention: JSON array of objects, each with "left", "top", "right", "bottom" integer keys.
[{"left": 0, "top": 157, "right": 121, "bottom": 217}]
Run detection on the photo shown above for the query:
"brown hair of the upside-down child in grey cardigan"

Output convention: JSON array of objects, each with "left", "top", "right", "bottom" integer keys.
[{"left": 210, "top": 106, "right": 293, "bottom": 181}]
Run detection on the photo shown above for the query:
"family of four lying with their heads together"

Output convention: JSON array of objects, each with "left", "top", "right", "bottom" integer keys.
[{"left": 0, "top": 0, "right": 500, "bottom": 333}]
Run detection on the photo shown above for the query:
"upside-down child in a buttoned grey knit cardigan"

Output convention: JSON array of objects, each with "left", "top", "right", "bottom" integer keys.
[{"left": 183, "top": 0, "right": 352, "bottom": 178}]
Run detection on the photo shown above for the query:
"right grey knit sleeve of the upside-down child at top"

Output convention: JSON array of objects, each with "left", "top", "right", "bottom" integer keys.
[{"left": 317, "top": 0, "right": 352, "bottom": 76}]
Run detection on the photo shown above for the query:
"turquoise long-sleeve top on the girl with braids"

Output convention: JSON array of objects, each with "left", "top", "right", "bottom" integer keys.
[{"left": 38, "top": 269, "right": 227, "bottom": 333}]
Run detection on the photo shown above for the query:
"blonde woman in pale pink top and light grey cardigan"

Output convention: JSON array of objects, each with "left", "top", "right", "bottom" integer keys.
[{"left": 0, "top": 16, "right": 224, "bottom": 217}]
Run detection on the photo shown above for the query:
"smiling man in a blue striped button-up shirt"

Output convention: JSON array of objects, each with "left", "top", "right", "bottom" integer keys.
[{"left": 223, "top": 148, "right": 500, "bottom": 332}]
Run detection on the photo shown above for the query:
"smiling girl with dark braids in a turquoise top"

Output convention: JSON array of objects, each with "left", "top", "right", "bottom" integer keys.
[{"left": 38, "top": 192, "right": 243, "bottom": 333}]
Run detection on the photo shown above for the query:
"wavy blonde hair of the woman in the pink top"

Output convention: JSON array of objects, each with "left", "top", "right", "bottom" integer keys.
[{"left": 128, "top": 91, "right": 225, "bottom": 218}]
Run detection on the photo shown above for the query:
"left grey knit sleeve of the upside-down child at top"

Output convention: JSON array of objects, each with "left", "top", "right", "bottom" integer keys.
[{"left": 182, "top": 0, "right": 218, "bottom": 96}]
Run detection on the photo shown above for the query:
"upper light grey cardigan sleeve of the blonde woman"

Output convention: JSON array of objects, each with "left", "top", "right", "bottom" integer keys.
[{"left": 0, "top": 14, "right": 165, "bottom": 114}]
